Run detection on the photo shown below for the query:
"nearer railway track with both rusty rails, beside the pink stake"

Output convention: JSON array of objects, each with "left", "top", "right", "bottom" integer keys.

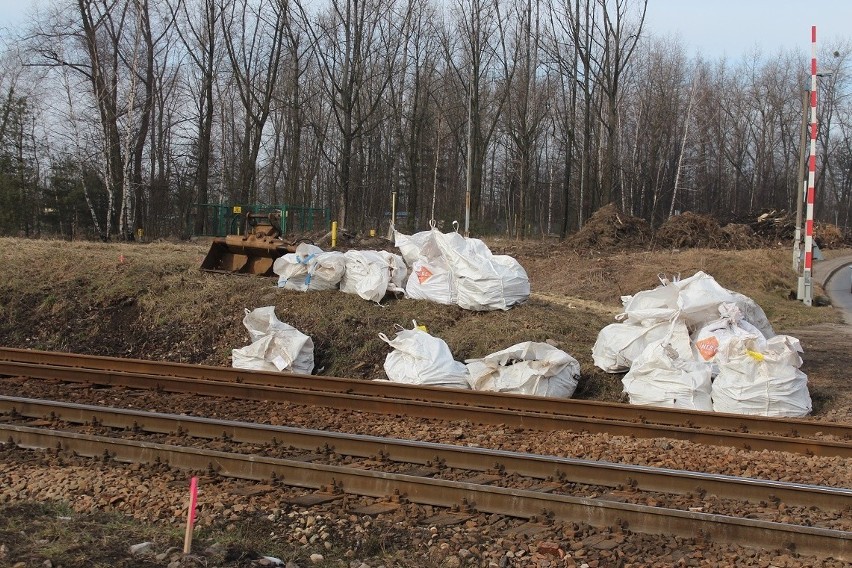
[{"left": 0, "top": 397, "right": 852, "bottom": 560}]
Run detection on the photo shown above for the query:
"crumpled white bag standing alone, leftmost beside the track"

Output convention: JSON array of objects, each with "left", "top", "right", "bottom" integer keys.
[{"left": 231, "top": 306, "right": 314, "bottom": 374}]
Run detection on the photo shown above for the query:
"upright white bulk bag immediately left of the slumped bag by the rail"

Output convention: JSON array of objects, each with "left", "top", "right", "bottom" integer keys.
[{"left": 379, "top": 322, "right": 470, "bottom": 389}]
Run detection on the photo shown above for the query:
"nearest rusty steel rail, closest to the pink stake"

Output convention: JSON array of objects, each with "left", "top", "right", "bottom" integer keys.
[{"left": 0, "top": 424, "right": 852, "bottom": 561}]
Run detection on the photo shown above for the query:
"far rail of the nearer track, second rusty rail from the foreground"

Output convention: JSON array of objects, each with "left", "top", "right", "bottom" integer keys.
[{"left": 0, "top": 396, "right": 852, "bottom": 511}]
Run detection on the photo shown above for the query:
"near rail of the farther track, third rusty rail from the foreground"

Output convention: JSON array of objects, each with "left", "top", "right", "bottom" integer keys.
[{"left": 0, "top": 361, "right": 852, "bottom": 457}]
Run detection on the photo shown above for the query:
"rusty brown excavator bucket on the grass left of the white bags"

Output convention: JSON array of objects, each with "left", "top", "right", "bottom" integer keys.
[{"left": 201, "top": 209, "right": 298, "bottom": 276}]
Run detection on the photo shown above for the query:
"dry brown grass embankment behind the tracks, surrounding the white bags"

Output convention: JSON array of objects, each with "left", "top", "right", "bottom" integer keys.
[{"left": 0, "top": 233, "right": 842, "bottom": 410}]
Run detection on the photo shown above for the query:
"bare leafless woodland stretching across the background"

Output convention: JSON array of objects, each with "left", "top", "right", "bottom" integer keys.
[{"left": 0, "top": 0, "right": 852, "bottom": 240}]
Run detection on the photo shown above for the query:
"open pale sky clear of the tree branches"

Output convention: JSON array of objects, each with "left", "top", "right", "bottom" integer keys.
[{"left": 0, "top": 0, "right": 852, "bottom": 60}]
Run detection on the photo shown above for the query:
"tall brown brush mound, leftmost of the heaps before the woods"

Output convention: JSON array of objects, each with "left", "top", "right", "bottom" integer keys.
[{"left": 566, "top": 203, "right": 651, "bottom": 251}]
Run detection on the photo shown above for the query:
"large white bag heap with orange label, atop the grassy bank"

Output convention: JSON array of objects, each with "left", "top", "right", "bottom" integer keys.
[{"left": 394, "top": 227, "right": 530, "bottom": 311}]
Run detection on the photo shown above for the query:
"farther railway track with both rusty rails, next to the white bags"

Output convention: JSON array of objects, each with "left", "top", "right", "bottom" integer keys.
[{"left": 0, "top": 348, "right": 852, "bottom": 457}]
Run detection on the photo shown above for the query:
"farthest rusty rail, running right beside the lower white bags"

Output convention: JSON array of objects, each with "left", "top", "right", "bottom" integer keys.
[{"left": 0, "top": 347, "right": 852, "bottom": 440}]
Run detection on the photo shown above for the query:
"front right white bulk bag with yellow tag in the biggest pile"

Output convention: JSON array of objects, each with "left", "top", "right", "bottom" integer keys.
[{"left": 712, "top": 335, "right": 812, "bottom": 416}]
